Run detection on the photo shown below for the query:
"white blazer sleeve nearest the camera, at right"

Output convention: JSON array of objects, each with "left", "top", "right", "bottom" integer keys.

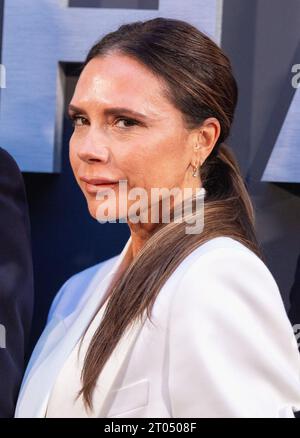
[{"left": 168, "top": 248, "right": 300, "bottom": 418}]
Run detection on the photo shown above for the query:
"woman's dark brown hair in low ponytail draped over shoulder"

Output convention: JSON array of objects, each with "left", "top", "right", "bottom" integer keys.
[{"left": 75, "top": 17, "right": 264, "bottom": 408}]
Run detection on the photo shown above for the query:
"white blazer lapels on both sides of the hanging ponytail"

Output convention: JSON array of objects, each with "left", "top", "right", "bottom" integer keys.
[{"left": 15, "top": 236, "right": 143, "bottom": 418}]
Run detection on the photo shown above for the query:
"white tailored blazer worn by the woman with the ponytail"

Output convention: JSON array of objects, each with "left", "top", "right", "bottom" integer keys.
[{"left": 15, "top": 237, "right": 300, "bottom": 418}]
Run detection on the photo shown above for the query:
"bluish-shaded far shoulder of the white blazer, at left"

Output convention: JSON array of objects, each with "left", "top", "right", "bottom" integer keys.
[{"left": 48, "top": 255, "right": 118, "bottom": 322}]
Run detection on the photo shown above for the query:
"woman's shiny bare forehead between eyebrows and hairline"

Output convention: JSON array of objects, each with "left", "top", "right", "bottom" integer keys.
[{"left": 72, "top": 54, "right": 174, "bottom": 115}]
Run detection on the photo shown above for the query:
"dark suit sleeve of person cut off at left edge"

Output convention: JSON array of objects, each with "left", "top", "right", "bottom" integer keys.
[{"left": 0, "top": 148, "right": 33, "bottom": 418}]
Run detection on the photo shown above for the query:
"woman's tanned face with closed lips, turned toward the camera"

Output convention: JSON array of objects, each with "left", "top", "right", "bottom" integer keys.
[{"left": 69, "top": 54, "right": 200, "bottom": 224}]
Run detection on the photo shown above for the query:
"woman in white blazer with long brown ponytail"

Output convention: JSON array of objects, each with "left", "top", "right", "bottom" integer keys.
[{"left": 16, "top": 18, "right": 300, "bottom": 418}]
